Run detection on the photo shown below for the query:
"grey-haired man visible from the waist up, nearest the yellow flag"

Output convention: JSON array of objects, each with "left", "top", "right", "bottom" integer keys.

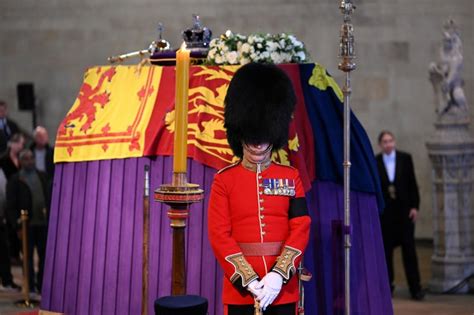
[{"left": 30, "top": 126, "right": 54, "bottom": 180}]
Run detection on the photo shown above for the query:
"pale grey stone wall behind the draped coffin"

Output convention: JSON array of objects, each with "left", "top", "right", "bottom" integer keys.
[{"left": 0, "top": 0, "right": 474, "bottom": 238}]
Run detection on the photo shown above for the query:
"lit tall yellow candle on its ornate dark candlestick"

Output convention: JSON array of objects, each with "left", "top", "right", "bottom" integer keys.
[{"left": 155, "top": 43, "right": 204, "bottom": 295}]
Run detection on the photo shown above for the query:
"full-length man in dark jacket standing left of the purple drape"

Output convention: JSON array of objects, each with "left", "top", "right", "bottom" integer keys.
[{"left": 7, "top": 149, "right": 51, "bottom": 292}]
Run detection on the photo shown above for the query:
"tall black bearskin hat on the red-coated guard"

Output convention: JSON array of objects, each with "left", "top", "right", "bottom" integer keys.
[{"left": 224, "top": 63, "right": 296, "bottom": 158}]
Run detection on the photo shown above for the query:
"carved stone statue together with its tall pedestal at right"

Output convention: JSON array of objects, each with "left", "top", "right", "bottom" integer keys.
[{"left": 426, "top": 21, "right": 474, "bottom": 293}]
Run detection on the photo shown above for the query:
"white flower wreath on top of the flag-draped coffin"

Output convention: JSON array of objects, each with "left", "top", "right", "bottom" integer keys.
[{"left": 207, "top": 30, "right": 310, "bottom": 65}]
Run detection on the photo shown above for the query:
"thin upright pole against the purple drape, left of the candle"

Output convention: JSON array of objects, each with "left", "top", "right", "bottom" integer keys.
[{"left": 142, "top": 165, "right": 150, "bottom": 315}]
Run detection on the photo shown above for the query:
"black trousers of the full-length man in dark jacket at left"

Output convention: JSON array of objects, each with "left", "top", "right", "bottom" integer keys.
[{"left": 28, "top": 225, "right": 48, "bottom": 291}]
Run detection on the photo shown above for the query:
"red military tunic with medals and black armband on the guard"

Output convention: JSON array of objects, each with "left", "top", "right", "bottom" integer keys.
[{"left": 208, "top": 163, "right": 311, "bottom": 305}]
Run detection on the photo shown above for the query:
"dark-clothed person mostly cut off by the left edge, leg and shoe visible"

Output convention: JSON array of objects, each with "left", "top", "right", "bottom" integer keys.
[{"left": 0, "top": 169, "right": 20, "bottom": 291}]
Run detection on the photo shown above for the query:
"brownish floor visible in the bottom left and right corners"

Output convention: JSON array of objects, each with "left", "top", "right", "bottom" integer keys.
[{"left": 0, "top": 243, "right": 474, "bottom": 315}]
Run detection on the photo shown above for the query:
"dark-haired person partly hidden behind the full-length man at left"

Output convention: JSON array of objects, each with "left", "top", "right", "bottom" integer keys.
[{"left": 0, "top": 133, "right": 25, "bottom": 265}]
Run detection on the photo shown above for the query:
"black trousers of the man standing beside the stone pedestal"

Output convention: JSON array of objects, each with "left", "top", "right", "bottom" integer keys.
[{"left": 381, "top": 204, "right": 421, "bottom": 295}]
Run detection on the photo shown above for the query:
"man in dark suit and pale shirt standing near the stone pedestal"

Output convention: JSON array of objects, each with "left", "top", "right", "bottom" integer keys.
[{"left": 376, "top": 131, "right": 424, "bottom": 300}]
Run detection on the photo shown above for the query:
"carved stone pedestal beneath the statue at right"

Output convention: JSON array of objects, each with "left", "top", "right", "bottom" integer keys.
[{"left": 426, "top": 120, "right": 474, "bottom": 293}]
